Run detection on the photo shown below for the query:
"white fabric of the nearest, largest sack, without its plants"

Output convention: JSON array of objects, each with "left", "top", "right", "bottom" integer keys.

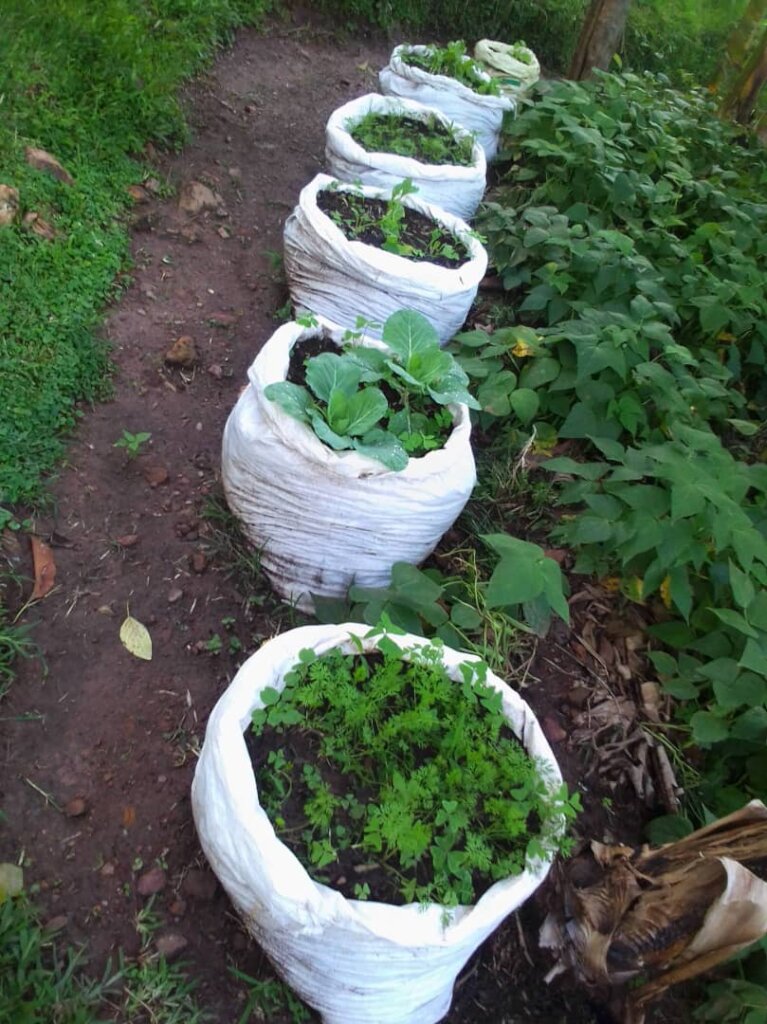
[{"left": 191, "top": 623, "right": 561, "bottom": 1024}]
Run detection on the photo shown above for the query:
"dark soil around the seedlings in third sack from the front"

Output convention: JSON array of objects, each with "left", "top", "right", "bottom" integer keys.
[{"left": 316, "top": 188, "right": 471, "bottom": 269}]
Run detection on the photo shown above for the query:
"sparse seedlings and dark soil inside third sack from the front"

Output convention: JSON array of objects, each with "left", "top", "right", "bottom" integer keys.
[{"left": 317, "top": 178, "right": 469, "bottom": 266}]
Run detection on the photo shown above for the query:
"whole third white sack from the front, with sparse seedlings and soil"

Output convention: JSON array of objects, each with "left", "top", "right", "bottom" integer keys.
[{"left": 285, "top": 174, "right": 487, "bottom": 344}]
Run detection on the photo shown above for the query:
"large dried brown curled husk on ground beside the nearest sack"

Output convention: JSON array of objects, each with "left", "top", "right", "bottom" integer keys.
[{"left": 541, "top": 800, "right": 767, "bottom": 1024}]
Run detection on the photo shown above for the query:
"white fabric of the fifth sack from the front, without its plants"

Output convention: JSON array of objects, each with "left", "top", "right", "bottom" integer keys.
[{"left": 378, "top": 45, "right": 516, "bottom": 163}]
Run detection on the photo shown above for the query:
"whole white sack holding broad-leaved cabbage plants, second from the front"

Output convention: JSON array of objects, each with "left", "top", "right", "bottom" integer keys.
[{"left": 221, "top": 310, "right": 477, "bottom": 610}]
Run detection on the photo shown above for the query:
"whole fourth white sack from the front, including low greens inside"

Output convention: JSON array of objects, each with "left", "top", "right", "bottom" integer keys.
[{"left": 325, "top": 93, "right": 486, "bottom": 220}]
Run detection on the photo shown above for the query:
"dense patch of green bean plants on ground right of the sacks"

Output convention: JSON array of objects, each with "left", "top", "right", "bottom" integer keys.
[{"left": 452, "top": 74, "right": 767, "bottom": 813}]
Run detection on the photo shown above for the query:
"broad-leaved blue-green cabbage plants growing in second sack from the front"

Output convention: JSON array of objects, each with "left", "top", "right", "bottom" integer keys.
[{"left": 264, "top": 309, "right": 476, "bottom": 470}]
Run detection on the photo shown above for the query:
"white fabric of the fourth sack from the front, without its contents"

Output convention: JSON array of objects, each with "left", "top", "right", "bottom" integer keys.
[{"left": 325, "top": 93, "right": 487, "bottom": 220}]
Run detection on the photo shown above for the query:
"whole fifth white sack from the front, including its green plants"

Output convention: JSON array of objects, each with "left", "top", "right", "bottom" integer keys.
[{"left": 378, "top": 41, "right": 516, "bottom": 162}]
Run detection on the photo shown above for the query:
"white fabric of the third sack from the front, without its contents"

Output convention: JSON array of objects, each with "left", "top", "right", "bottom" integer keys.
[{"left": 285, "top": 174, "right": 487, "bottom": 344}]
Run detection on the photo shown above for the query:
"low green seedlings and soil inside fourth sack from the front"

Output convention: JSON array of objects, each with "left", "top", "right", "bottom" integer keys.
[{"left": 346, "top": 111, "right": 473, "bottom": 167}]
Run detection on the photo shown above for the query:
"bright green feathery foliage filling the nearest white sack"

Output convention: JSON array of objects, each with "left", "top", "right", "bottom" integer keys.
[{"left": 248, "top": 627, "right": 578, "bottom": 906}]
